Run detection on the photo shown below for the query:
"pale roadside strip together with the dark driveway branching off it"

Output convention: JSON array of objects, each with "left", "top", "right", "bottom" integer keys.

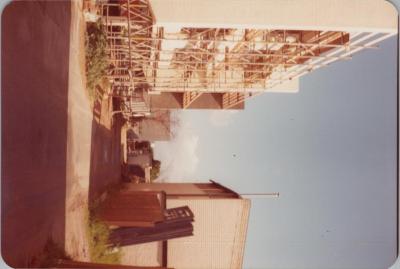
[{"left": 65, "top": 1, "right": 121, "bottom": 261}]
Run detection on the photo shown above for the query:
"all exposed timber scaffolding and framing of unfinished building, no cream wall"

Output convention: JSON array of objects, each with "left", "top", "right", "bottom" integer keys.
[{"left": 98, "top": 0, "right": 396, "bottom": 109}]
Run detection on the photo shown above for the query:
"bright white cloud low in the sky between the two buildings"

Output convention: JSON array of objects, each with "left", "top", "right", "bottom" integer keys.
[{"left": 154, "top": 116, "right": 199, "bottom": 182}]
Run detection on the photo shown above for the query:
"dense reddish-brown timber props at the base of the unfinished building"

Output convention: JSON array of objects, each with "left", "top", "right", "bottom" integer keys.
[{"left": 100, "top": 0, "right": 153, "bottom": 118}]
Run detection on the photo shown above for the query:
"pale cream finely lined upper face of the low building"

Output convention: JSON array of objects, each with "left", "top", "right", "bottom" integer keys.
[{"left": 167, "top": 198, "right": 250, "bottom": 269}]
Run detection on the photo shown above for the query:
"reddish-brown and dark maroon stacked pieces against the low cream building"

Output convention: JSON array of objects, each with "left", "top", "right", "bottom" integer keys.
[{"left": 98, "top": 191, "right": 194, "bottom": 246}]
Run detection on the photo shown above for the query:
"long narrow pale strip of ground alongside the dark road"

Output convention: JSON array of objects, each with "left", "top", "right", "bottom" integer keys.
[{"left": 64, "top": 1, "right": 93, "bottom": 261}]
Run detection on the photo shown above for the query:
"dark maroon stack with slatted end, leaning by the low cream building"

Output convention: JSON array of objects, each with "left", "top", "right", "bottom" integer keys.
[{"left": 109, "top": 206, "right": 194, "bottom": 246}]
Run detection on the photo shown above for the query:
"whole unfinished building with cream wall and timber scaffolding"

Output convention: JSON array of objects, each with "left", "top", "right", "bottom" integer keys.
[{"left": 87, "top": 0, "right": 397, "bottom": 116}]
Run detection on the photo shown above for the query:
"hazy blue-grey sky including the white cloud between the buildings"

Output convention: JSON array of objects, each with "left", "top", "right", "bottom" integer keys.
[{"left": 155, "top": 37, "right": 397, "bottom": 269}]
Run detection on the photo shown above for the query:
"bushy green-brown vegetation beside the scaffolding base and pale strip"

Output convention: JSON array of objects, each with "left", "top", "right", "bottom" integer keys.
[{"left": 85, "top": 20, "right": 109, "bottom": 100}]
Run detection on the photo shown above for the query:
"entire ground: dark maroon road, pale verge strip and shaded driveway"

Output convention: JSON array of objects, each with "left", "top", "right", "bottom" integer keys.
[{"left": 1, "top": 1, "right": 121, "bottom": 267}]
